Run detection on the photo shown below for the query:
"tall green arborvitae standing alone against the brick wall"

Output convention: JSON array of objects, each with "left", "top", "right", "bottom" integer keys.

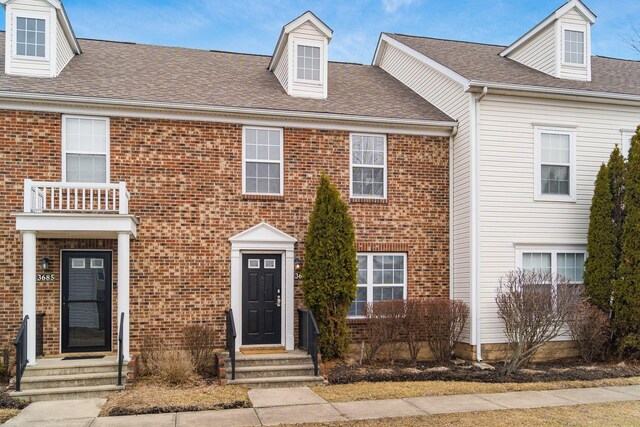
[{"left": 302, "top": 174, "right": 358, "bottom": 359}]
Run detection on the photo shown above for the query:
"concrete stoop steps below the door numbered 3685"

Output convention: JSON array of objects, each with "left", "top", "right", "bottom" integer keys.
[{"left": 9, "top": 356, "right": 128, "bottom": 402}]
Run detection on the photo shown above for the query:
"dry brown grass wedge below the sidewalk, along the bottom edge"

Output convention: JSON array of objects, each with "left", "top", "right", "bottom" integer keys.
[{"left": 284, "top": 402, "right": 640, "bottom": 427}]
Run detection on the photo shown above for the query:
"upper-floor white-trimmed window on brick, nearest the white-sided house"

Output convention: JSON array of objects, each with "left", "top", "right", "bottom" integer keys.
[{"left": 351, "top": 133, "right": 387, "bottom": 199}]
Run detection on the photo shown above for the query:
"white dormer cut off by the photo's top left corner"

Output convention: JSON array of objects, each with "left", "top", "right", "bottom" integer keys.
[{"left": 0, "top": 0, "right": 82, "bottom": 77}]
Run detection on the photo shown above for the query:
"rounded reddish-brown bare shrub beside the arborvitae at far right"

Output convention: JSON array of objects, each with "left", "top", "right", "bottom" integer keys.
[{"left": 567, "top": 302, "right": 611, "bottom": 362}]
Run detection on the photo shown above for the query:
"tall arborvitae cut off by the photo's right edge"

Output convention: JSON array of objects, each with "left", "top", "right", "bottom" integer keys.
[{"left": 614, "top": 126, "right": 640, "bottom": 356}]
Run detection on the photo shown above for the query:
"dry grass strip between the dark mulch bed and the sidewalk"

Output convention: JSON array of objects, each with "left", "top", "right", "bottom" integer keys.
[{"left": 313, "top": 377, "right": 640, "bottom": 402}]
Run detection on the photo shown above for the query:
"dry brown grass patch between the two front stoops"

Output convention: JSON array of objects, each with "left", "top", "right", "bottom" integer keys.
[{"left": 100, "top": 380, "right": 251, "bottom": 416}]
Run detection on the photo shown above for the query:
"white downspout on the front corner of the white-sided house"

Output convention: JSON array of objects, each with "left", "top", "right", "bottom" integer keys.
[{"left": 471, "top": 86, "right": 489, "bottom": 362}]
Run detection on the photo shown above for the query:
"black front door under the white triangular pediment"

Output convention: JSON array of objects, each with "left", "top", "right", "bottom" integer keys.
[{"left": 242, "top": 255, "right": 282, "bottom": 345}]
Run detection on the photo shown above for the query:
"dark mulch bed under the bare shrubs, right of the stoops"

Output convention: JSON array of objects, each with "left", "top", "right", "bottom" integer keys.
[{"left": 326, "top": 359, "right": 640, "bottom": 384}]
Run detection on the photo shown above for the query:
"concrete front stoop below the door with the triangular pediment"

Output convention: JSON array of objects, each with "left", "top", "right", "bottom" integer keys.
[{"left": 218, "top": 350, "right": 324, "bottom": 388}]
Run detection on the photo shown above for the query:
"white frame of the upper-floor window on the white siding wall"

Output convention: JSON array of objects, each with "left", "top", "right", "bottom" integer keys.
[{"left": 533, "top": 126, "right": 577, "bottom": 202}]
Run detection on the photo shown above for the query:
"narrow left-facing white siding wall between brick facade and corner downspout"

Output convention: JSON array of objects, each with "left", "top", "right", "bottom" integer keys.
[{"left": 380, "top": 39, "right": 473, "bottom": 342}]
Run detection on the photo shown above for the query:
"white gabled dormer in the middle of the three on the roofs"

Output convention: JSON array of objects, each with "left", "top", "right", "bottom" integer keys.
[{"left": 269, "top": 12, "right": 333, "bottom": 98}]
